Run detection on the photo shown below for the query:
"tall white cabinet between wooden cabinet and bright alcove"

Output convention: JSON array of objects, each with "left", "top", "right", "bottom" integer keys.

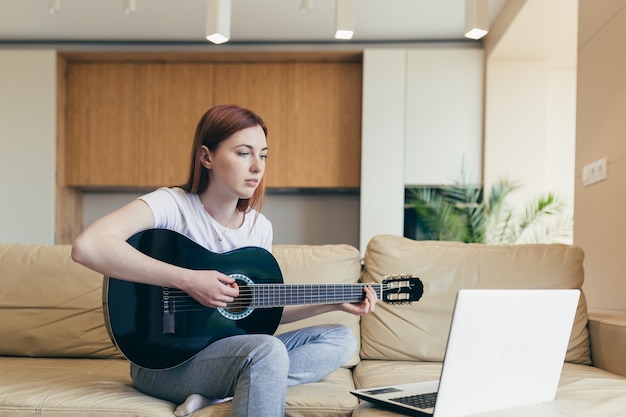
[{"left": 360, "top": 46, "right": 484, "bottom": 252}]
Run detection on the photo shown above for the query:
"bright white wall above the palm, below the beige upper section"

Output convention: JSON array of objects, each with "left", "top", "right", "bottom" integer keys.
[{"left": 484, "top": 59, "right": 576, "bottom": 214}]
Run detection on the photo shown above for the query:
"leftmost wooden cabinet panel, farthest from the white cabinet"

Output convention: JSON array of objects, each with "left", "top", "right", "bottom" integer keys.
[{"left": 66, "top": 63, "right": 141, "bottom": 186}]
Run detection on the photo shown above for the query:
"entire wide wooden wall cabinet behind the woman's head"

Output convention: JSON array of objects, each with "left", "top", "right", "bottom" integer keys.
[{"left": 66, "top": 54, "right": 362, "bottom": 189}]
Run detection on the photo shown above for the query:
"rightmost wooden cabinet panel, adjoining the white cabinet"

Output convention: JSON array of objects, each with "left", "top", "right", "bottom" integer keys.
[{"left": 286, "top": 63, "right": 362, "bottom": 187}]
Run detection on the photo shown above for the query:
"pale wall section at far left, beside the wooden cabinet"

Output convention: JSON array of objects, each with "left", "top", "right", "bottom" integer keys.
[{"left": 0, "top": 50, "right": 56, "bottom": 244}]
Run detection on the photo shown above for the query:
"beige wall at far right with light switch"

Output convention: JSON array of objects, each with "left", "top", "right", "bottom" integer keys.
[{"left": 574, "top": 0, "right": 626, "bottom": 312}]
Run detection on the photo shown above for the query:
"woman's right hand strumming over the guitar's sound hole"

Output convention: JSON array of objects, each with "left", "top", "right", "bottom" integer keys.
[{"left": 179, "top": 270, "right": 239, "bottom": 308}]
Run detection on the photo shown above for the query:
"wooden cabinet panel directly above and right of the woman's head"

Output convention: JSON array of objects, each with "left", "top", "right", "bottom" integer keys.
[{"left": 214, "top": 63, "right": 288, "bottom": 187}]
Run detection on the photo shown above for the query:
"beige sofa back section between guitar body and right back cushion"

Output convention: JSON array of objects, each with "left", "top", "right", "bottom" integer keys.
[{"left": 272, "top": 245, "right": 361, "bottom": 366}]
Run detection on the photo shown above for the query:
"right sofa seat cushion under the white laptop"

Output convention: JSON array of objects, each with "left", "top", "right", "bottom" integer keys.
[{"left": 354, "top": 360, "right": 626, "bottom": 417}]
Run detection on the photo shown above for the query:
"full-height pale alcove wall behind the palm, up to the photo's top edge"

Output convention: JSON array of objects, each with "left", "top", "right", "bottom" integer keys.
[{"left": 484, "top": 0, "right": 578, "bottom": 243}]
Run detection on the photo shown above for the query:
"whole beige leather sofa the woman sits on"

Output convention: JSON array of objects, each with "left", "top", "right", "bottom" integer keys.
[{"left": 0, "top": 235, "right": 626, "bottom": 417}]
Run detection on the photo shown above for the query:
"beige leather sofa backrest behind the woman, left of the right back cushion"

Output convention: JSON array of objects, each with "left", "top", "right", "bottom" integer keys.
[{"left": 0, "top": 240, "right": 361, "bottom": 366}]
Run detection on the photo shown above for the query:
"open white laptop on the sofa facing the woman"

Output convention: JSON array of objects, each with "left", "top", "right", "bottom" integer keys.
[{"left": 350, "top": 289, "right": 580, "bottom": 417}]
